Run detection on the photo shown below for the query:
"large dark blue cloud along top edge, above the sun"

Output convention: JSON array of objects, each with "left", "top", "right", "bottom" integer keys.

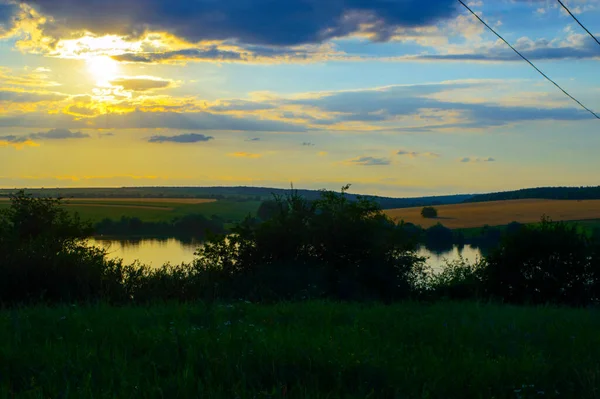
[{"left": 23, "top": 0, "right": 457, "bottom": 45}]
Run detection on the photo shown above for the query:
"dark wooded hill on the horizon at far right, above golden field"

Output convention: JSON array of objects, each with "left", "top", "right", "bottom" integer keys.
[{"left": 464, "top": 186, "right": 600, "bottom": 202}]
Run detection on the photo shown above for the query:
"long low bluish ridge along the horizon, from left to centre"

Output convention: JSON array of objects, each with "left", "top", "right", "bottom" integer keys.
[{"left": 0, "top": 186, "right": 472, "bottom": 209}]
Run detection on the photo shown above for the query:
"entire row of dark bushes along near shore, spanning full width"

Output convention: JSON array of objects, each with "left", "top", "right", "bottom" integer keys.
[{"left": 0, "top": 187, "right": 600, "bottom": 306}]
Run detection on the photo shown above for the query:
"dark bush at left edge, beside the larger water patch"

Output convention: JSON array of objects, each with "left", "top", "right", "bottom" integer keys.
[{"left": 0, "top": 191, "right": 120, "bottom": 303}]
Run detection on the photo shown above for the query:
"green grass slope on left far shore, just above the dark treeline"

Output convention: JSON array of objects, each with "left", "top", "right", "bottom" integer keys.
[{"left": 0, "top": 199, "right": 260, "bottom": 222}]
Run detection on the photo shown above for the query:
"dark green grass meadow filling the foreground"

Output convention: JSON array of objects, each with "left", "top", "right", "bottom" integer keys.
[{"left": 0, "top": 302, "right": 600, "bottom": 399}]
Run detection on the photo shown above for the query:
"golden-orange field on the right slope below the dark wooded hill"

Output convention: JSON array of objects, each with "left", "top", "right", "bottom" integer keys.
[{"left": 385, "top": 199, "right": 600, "bottom": 229}]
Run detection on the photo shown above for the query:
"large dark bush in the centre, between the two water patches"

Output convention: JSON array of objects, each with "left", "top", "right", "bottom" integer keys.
[{"left": 196, "top": 186, "right": 424, "bottom": 301}]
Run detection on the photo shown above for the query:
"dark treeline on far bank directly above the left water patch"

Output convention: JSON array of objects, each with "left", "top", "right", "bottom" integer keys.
[{"left": 94, "top": 215, "right": 225, "bottom": 239}]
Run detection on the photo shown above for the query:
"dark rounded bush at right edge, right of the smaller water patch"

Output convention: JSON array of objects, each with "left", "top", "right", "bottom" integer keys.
[{"left": 484, "top": 218, "right": 600, "bottom": 305}]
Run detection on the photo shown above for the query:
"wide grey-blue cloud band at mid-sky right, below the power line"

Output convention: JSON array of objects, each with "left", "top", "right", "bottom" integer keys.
[{"left": 281, "top": 81, "right": 590, "bottom": 132}]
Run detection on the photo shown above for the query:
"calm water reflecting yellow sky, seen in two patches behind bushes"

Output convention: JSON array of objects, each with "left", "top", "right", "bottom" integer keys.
[{"left": 89, "top": 238, "right": 481, "bottom": 270}]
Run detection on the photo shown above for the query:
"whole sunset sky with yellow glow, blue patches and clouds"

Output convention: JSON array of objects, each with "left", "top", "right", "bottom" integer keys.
[{"left": 0, "top": 0, "right": 600, "bottom": 197}]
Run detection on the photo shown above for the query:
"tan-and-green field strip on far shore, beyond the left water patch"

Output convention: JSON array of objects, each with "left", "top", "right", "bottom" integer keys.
[{"left": 0, "top": 198, "right": 260, "bottom": 222}]
